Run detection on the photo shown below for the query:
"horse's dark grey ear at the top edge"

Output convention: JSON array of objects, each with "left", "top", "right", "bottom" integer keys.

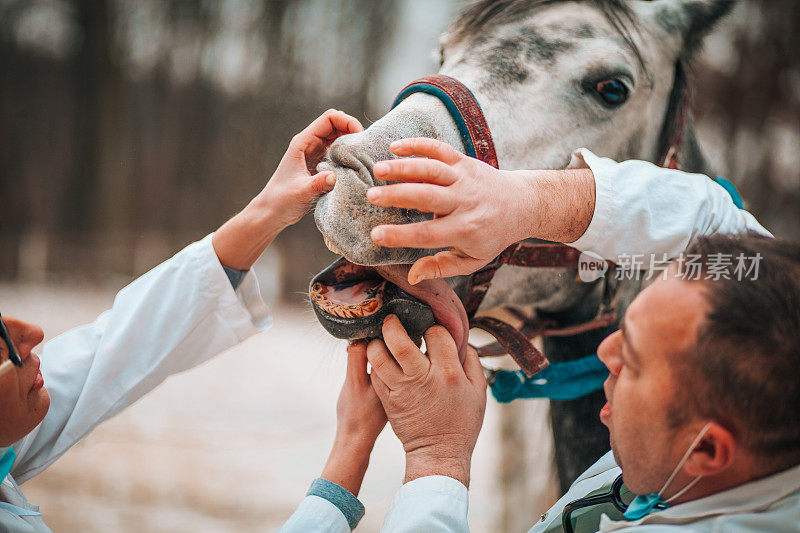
[{"left": 648, "top": 0, "right": 736, "bottom": 57}]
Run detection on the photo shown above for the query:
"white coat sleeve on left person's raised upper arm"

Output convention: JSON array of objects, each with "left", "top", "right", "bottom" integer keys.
[{"left": 12, "top": 235, "right": 271, "bottom": 483}]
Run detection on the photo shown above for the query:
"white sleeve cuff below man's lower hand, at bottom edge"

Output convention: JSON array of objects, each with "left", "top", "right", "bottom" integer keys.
[{"left": 381, "top": 476, "right": 469, "bottom": 533}]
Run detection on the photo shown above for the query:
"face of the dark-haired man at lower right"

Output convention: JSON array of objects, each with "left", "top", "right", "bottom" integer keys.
[{"left": 597, "top": 268, "right": 709, "bottom": 494}]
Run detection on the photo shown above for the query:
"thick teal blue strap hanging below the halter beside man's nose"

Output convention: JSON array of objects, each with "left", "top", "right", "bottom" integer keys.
[{"left": 491, "top": 354, "right": 608, "bottom": 403}]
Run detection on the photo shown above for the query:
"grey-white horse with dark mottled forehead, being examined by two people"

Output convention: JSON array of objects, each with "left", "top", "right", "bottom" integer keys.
[{"left": 314, "top": 0, "right": 733, "bottom": 490}]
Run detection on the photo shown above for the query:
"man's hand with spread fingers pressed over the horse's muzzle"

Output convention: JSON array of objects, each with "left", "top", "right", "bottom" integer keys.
[{"left": 367, "top": 138, "right": 536, "bottom": 284}]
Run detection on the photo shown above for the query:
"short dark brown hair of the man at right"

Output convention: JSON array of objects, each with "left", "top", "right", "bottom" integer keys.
[{"left": 675, "top": 234, "right": 800, "bottom": 474}]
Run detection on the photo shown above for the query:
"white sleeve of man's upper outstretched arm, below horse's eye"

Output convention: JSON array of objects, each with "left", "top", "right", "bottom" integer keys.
[{"left": 569, "top": 148, "right": 771, "bottom": 261}]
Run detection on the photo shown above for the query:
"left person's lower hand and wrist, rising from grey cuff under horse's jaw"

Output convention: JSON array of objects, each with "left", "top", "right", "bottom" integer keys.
[{"left": 321, "top": 341, "right": 386, "bottom": 496}]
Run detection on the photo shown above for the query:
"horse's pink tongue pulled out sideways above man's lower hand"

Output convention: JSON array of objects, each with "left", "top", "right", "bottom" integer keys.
[{"left": 376, "top": 265, "right": 469, "bottom": 362}]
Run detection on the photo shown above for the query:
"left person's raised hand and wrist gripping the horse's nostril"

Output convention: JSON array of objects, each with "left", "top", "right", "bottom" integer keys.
[{"left": 212, "top": 109, "right": 364, "bottom": 270}]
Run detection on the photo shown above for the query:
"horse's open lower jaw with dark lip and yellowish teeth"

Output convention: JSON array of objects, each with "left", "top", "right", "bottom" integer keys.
[{"left": 309, "top": 257, "right": 435, "bottom": 341}]
